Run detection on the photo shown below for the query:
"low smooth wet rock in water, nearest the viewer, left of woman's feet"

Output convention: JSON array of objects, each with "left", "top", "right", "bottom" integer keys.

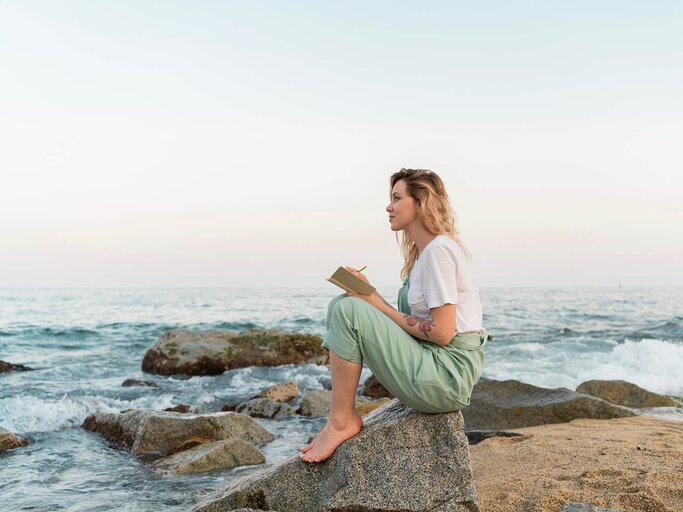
[{"left": 154, "top": 439, "right": 266, "bottom": 475}]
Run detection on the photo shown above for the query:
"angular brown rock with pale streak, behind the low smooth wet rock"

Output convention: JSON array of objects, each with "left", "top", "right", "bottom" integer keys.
[{"left": 82, "top": 409, "right": 274, "bottom": 456}]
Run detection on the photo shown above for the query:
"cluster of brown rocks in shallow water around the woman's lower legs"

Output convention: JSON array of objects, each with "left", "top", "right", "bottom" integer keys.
[{"left": 82, "top": 381, "right": 388, "bottom": 474}]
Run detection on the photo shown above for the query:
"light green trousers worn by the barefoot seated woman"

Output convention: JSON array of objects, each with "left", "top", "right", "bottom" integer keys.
[{"left": 322, "top": 278, "right": 486, "bottom": 413}]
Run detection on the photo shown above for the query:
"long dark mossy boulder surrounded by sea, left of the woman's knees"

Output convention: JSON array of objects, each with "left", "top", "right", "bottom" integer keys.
[{"left": 142, "top": 329, "right": 328, "bottom": 375}]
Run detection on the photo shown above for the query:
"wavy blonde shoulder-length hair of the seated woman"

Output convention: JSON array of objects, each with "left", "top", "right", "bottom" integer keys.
[{"left": 389, "top": 169, "right": 472, "bottom": 279}]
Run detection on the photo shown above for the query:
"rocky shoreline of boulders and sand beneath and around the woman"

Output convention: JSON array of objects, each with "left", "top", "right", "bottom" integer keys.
[{"left": 0, "top": 330, "right": 683, "bottom": 512}]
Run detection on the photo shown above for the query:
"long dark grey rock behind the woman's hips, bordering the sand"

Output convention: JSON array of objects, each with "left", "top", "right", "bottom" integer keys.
[{"left": 462, "top": 378, "right": 636, "bottom": 430}]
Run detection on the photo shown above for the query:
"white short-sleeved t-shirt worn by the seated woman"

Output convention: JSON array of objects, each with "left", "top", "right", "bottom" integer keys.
[{"left": 408, "top": 235, "right": 483, "bottom": 332}]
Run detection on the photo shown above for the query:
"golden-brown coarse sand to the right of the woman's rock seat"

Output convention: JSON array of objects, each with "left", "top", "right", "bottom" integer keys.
[{"left": 470, "top": 416, "right": 683, "bottom": 512}]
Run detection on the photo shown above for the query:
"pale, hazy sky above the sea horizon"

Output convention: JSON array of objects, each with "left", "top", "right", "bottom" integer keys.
[{"left": 0, "top": 0, "right": 683, "bottom": 288}]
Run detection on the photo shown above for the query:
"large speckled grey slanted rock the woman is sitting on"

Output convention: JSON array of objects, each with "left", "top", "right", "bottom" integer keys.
[{"left": 194, "top": 400, "right": 479, "bottom": 512}]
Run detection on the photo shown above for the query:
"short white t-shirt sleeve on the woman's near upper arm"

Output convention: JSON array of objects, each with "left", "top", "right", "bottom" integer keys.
[{"left": 422, "top": 245, "right": 458, "bottom": 309}]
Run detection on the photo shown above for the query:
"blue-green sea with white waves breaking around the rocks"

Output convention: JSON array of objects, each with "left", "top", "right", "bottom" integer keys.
[{"left": 0, "top": 286, "right": 683, "bottom": 512}]
